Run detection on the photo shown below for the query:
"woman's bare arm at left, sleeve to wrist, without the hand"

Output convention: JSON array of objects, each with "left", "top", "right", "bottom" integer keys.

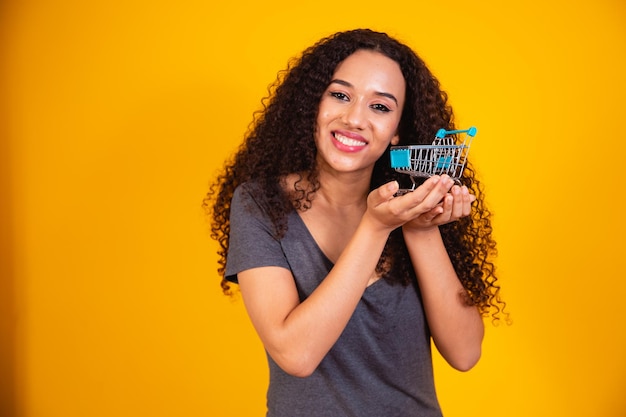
[{"left": 242, "top": 217, "right": 389, "bottom": 376}]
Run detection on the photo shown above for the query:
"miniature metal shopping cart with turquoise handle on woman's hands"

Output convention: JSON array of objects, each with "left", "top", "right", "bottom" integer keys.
[{"left": 391, "top": 127, "right": 476, "bottom": 194}]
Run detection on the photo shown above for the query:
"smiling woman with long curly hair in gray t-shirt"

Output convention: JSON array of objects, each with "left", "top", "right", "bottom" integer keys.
[{"left": 204, "top": 30, "right": 502, "bottom": 417}]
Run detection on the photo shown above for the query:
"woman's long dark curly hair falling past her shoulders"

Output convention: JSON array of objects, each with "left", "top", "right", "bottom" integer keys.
[{"left": 203, "top": 29, "right": 505, "bottom": 321}]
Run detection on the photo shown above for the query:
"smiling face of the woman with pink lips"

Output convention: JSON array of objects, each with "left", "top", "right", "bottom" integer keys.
[{"left": 315, "top": 50, "right": 405, "bottom": 173}]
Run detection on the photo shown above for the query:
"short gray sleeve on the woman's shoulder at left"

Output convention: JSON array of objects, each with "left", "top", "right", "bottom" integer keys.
[{"left": 225, "top": 184, "right": 289, "bottom": 283}]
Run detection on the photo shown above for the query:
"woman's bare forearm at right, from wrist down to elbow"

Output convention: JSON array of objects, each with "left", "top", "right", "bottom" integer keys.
[{"left": 404, "top": 227, "right": 484, "bottom": 370}]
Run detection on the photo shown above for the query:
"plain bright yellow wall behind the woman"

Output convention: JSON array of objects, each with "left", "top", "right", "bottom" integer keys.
[{"left": 0, "top": 0, "right": 626, "bottom": 417}]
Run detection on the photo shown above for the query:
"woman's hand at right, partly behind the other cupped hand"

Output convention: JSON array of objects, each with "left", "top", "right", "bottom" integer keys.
[{"left": 404, "top": 178, "right": 476, "bottom": 230}]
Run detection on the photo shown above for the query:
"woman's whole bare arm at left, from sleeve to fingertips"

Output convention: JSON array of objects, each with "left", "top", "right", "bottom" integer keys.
[{"left": 238, "top": 178, "right": 447, "bottom": 376}]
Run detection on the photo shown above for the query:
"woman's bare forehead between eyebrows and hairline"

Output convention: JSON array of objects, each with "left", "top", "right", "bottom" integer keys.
[{"left": 333, "top": 50, "right": 405, "bottom": 94}]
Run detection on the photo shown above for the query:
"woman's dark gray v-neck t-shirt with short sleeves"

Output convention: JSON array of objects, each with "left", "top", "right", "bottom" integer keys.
[{"left": 226, "top": 183, "right": 442, "bottom": 417}]
